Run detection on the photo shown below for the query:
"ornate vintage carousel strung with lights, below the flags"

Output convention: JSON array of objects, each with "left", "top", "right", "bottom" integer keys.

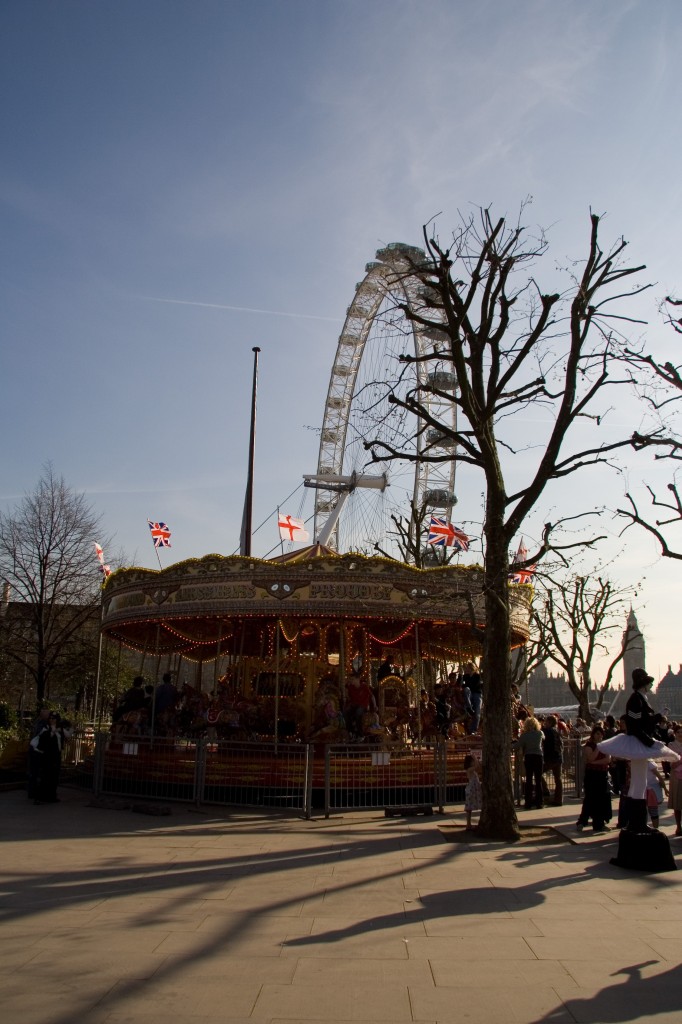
[{"left": 102, "top": 545, "right": 530, "bottom": 743}]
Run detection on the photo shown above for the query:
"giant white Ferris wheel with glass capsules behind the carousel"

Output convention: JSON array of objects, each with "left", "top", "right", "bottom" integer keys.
[{"left": 304, "top": 243, "right": 457, "bottom": 556}]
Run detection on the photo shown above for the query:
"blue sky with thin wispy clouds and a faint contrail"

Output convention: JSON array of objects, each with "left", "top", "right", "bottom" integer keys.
[{"left": 0, "top": 0, "right": 682, "bottom": 684}]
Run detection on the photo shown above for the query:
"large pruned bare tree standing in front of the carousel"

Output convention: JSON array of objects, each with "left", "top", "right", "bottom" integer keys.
[{"left": 366, "top": 210, "right": 648, "bottom": 840}]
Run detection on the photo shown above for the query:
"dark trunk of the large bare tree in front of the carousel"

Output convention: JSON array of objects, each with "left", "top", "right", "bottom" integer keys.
[{"left": 478, "top": 487, "right": 519, "bottom": 842}]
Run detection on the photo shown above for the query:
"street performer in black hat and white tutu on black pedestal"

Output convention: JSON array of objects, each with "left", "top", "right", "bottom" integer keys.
[{"left": 597, "top": 669, "right": 680, "bottom": 833}]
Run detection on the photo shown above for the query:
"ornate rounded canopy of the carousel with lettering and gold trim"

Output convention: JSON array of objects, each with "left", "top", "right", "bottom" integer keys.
[{"left": 102, "top": 545, "right": 531, "bottom": 659}]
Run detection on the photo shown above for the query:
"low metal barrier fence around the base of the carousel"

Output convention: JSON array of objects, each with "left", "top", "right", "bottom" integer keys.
[{"left": 62, "top": 732, "right": 583, "bottom": 817}]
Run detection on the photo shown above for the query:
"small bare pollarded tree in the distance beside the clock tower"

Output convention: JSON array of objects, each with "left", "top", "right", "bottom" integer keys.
[{"left": 532, "top": 574, "right": 638, "bottom": 722}]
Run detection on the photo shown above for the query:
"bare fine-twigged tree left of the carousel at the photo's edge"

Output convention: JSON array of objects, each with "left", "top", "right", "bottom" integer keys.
[{"left": 0, "top": 465, "right": 101, "bottom": 703}]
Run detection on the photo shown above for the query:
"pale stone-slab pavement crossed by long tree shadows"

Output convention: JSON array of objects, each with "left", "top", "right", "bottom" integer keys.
[{"left": 0, "top": 787, "right": 682, "bottom": 1024}]
